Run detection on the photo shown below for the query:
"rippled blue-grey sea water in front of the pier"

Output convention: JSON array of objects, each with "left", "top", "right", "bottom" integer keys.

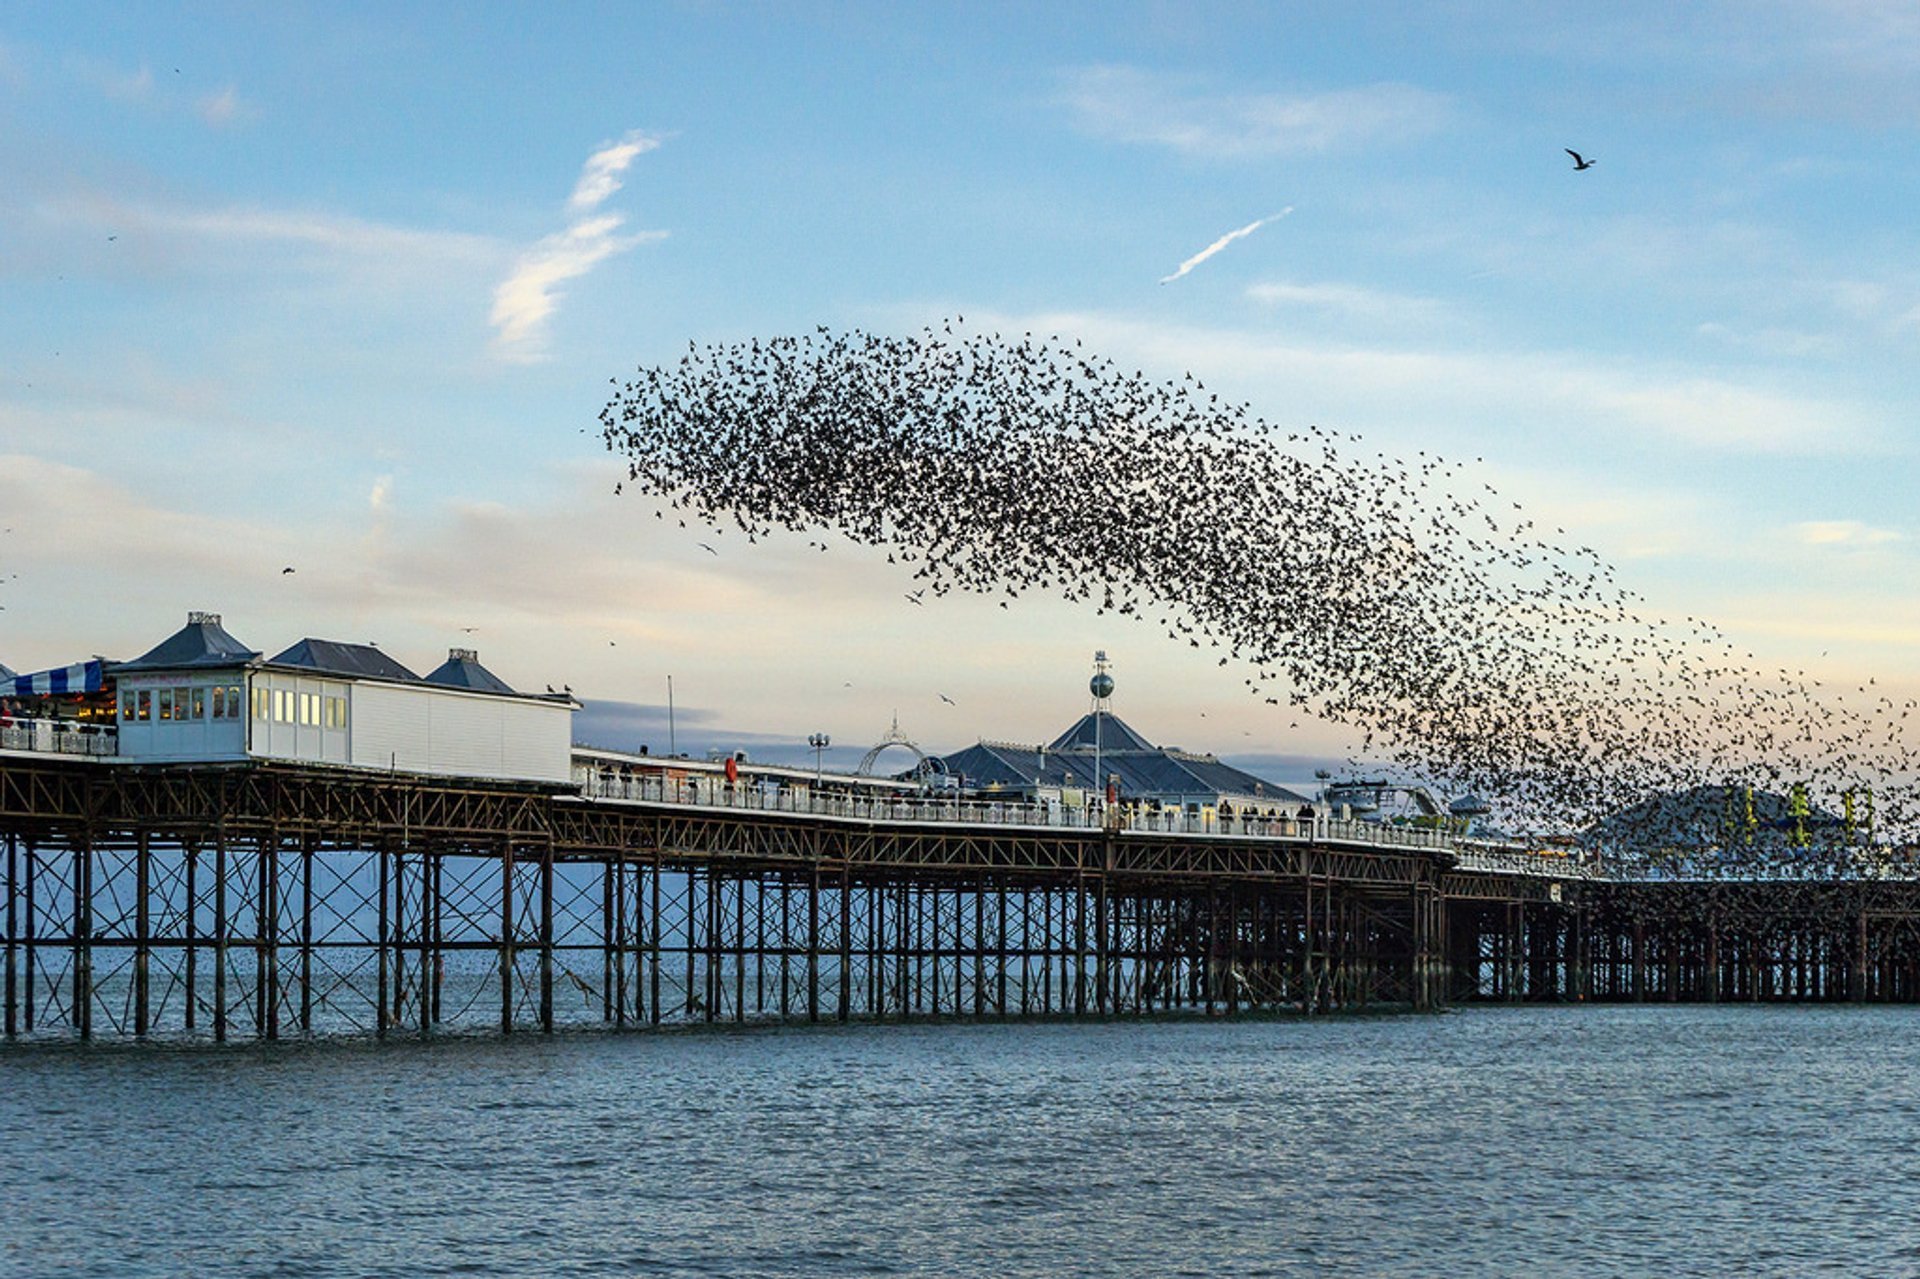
[{"left": 0, "top": 1006, "right": 1920, "bottom": 1277}]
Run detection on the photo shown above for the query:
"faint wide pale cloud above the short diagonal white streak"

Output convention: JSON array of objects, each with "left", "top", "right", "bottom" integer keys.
[{"left": 1060, "top": 67, "right": 1448, "bottom": 159}]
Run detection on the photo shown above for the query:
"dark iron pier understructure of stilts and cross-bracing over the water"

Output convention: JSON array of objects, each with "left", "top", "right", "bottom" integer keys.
[{"left": 0, "top": 751, "right": 1920, "bottom": 1041}]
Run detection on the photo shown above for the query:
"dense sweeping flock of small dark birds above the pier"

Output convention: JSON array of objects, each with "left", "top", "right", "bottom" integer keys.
[{"left": 601, "top": 321, "right": 1920, "bottom": 870}]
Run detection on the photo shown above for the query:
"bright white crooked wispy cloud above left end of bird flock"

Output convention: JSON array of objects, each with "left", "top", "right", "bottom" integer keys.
[{"left": 488, "top": 133, "right": 666, "bottom": 365}]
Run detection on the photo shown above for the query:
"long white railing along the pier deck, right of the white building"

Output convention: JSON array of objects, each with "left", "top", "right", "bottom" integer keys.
[{"left": 576, "top": 774, "right": 1453, "bottom": 849}]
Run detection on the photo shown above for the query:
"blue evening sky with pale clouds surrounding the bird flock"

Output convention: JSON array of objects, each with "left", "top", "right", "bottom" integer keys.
[{"left": 0, "top": 0, "right": 1920, "bottom": 782}]
